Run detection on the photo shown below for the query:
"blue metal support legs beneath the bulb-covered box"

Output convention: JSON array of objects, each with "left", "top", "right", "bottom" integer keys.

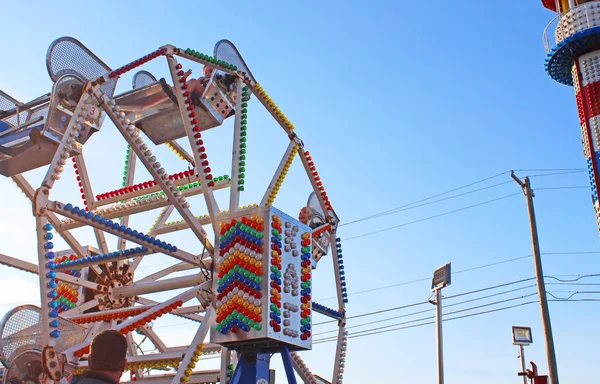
[{"left": 231, "top": 345, "right": 297, "bottom": 384}]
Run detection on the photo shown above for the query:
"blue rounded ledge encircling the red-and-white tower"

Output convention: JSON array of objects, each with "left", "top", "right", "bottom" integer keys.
[{"left": 545, "top": 27, "right": 600, "bottom": 86}]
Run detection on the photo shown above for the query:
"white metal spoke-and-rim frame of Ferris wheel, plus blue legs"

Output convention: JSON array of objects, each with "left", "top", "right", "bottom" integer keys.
[{"left": 0, "top": 41, "right": 345, "bottom": 384}]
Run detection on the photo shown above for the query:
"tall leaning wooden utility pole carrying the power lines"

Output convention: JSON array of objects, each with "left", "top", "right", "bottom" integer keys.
[{"left": 510, "top": 171, "right": 559, "bottom": 384}]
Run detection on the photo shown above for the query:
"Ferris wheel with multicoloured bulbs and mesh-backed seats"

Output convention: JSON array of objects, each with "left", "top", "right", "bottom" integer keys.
[{"left": 0, "top": 37, "right": 347, "bottom": 384}]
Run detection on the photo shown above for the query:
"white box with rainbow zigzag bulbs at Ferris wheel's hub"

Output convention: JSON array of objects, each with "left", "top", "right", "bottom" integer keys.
[{"left": 210, "top": 207, "right": 312, "bottom": 351}]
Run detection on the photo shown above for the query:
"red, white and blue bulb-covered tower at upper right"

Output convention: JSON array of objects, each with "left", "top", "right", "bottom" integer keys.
[{"left": 542, "top": 0, "right": 600, "bottom": 228}]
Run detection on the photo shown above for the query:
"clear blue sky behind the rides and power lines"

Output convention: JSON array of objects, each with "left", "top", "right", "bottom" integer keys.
[{"left": 0, "top": 0, "right": 600, "bottom": 384}]
